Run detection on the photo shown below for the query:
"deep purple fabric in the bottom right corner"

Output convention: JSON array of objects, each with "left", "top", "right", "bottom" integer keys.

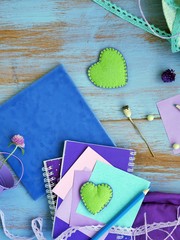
[{"left": 133, "top": 192, "right": 180, "bottom": 240}]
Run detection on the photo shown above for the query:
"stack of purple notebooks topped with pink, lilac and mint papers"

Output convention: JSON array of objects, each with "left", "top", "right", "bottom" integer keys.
[{"left": 44, "top": 140, "right": 150, "bottom": 240}]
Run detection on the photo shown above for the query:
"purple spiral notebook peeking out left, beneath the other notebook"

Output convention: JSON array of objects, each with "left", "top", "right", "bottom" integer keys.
[{"left": 42, "top": 158, "right": 62, "bottom": 220}]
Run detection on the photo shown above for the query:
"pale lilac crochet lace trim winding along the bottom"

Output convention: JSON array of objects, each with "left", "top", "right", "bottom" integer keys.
[{"left": 0, "top": 206, "right": 180, "bottom": 240}]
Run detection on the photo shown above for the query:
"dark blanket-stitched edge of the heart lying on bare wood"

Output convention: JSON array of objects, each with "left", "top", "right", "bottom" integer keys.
[{"left": 88, "top": 48, "right": 128, "bottom": 88}]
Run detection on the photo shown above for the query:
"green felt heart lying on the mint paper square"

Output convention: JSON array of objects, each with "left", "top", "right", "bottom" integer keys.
[{"left": 80, "top": 182, "right": 113, "bottom": 214}]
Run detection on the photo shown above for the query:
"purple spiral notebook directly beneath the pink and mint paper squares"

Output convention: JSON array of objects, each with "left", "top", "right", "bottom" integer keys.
[{"left": 53, "top": 140, "right": 136, "bottom": 240}]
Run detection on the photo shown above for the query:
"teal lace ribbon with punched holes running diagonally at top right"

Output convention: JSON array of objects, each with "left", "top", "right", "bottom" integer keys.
[{"left": 92, "top": 0, "right": 180, "bottom": 52}]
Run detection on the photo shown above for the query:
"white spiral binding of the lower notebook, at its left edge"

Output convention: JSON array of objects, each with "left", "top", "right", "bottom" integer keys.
[{"left": 42, "top": 166, "right": 57, "bottom": 220}]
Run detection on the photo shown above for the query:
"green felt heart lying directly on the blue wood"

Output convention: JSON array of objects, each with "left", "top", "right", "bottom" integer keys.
[{"left": 88, "top": 48, "right": 127, "bottom": 88}]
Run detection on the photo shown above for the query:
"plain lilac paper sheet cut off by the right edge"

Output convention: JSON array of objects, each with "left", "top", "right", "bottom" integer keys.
[{"left": 157, "top": 95, "right": 180, "bottom": 154}]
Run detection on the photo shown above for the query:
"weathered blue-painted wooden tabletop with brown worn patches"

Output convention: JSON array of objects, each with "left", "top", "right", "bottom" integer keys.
[{"left": 0, "top": 0, "right": 180, "bottom": 240}]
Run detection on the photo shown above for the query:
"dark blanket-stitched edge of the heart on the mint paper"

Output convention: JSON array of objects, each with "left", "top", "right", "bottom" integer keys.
[{"left": 80, "top": 181, "right": 113, "bottom": 215}]
